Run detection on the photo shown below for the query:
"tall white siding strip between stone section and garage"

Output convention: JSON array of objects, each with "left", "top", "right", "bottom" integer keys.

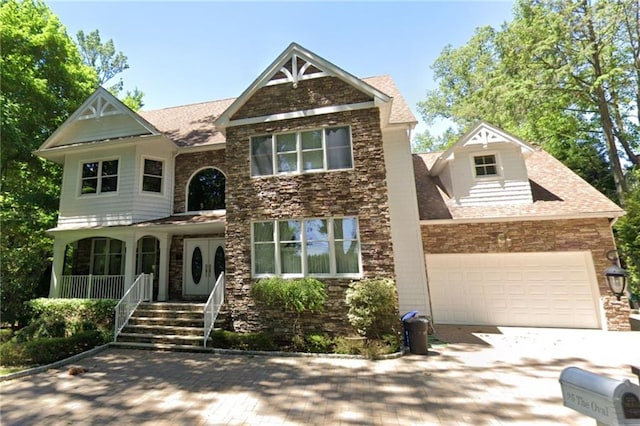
[{"left": 383, "top": 129, "right": 431, "bottom": 314}]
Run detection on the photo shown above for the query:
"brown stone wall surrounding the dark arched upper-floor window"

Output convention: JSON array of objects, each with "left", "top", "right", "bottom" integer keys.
[{"left": 173, "top": 149, "right": 226, "bottom": 213}]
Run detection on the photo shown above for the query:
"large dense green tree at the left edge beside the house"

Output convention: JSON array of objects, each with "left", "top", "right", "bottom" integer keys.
[{"left": 0, "top": 0, "right": 97, "bottom": 323}]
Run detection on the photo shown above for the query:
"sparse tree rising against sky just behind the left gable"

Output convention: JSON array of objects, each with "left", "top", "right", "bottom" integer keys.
[{"left": 76, "top": 30, "right": 144, "bottom": 111}]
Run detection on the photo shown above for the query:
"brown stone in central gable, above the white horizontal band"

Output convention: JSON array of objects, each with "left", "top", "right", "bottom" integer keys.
[{"left": 231, "top": 77, "right": 373, "bottom": 120}]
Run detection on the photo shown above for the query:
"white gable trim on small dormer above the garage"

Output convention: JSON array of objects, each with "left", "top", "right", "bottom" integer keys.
[{"left": 431, "top": 121, "right": 536, "bottom": 175}]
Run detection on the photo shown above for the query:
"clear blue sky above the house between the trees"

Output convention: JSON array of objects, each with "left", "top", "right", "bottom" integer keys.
[{"left": 47, "top": 1, "right": 513, "bottom": 133}]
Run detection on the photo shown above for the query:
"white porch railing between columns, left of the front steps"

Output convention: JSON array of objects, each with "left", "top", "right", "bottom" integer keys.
[{"left": 59, "top": 275, "right": 125, "bottom": 299}]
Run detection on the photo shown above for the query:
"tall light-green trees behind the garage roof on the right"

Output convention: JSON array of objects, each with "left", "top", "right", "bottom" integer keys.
[{"left": 419, "top": 0, "right": 640, "bottom": 200}]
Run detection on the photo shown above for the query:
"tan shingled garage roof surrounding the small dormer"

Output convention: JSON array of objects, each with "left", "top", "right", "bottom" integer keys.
[{"left": 413, "top": 150, "right": 624, "bottom": 222}]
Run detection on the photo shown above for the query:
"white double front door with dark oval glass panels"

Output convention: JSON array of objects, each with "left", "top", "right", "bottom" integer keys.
[{"left": 183, "top": 238, "right": 224, "bottom": 296}]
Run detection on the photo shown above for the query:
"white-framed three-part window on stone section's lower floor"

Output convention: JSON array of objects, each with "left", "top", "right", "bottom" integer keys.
[{"left": 252, "top": 217, "right": 362, "bottom": 278}]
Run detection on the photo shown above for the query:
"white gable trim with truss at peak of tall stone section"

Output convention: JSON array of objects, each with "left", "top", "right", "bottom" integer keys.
[{"left": 215, "top": 43, "right": 391, "bottom": 131}]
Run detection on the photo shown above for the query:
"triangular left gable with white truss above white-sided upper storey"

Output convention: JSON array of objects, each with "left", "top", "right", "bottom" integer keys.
[{"left": 36, "top": 87, "right": 160, "bottom": 154}]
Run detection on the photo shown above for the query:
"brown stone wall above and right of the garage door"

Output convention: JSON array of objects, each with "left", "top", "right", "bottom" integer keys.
[{"left": 421, "top": 218, "right": 629, "bottom": 330}]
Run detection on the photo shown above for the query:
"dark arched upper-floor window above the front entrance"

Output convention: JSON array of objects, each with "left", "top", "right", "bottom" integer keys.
[{"left": 187, "top": 168, "right": 226, "bottom": 212}]
